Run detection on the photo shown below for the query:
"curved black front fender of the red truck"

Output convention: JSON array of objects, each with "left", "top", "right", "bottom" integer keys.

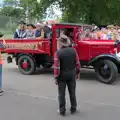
[{"left": 88, "top": 54, "right": 120, "bottom": 65}]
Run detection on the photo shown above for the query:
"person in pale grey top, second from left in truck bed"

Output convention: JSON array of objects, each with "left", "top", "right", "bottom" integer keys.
[{"left": 26, "top": 24, "right": 35, "bottom": 39}]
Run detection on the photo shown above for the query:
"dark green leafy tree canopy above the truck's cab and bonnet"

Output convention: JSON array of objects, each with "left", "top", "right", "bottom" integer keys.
[{"left": 37, "top": 0, "right": 120, "bottom": 24}]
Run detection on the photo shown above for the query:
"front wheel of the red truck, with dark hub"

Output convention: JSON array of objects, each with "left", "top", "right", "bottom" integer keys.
[{"left": 95, "top": 60, "right": 118, "bottom": 84}]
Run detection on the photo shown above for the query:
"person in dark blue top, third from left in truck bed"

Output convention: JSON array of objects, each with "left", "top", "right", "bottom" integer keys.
[{"left": 35, "top": 23, "right": 45, "bottom": 39}]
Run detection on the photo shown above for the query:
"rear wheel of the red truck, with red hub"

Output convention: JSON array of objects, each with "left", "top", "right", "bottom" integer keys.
[{"left": 18, "top": 55, "right": 36, "bottom": 75}]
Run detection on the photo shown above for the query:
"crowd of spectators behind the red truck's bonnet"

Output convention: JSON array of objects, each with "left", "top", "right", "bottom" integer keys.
[{"left": 80, "top": 25, "right": 120, "bottom": 40}]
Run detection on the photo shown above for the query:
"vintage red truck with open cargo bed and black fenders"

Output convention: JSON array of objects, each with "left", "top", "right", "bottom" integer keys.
[{"left": 1, "top": 23, "right": 120, "bottom": 84}]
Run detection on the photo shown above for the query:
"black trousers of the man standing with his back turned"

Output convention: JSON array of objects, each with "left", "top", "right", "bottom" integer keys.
[{"left": 58, "top": 76, "right": 77, "bottom": 112}]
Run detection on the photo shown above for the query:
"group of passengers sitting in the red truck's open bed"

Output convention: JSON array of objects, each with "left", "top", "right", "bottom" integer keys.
[{"left": 14, "top": 21, "right": 51, "bottom": 39}]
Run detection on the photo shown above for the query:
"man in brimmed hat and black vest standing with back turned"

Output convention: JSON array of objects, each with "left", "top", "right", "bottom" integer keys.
[{"left": 54, "top": 35, "right": 80, "bottom": 116}]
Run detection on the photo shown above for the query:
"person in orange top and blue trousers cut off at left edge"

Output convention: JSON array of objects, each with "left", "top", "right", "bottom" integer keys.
[{"left": 0, "top": 33, "right": 5, "bottom": 96}]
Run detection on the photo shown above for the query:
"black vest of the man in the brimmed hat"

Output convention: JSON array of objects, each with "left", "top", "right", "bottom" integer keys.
[{"left": 57, "top": 47, "right": 76, "bottom": 80}]
